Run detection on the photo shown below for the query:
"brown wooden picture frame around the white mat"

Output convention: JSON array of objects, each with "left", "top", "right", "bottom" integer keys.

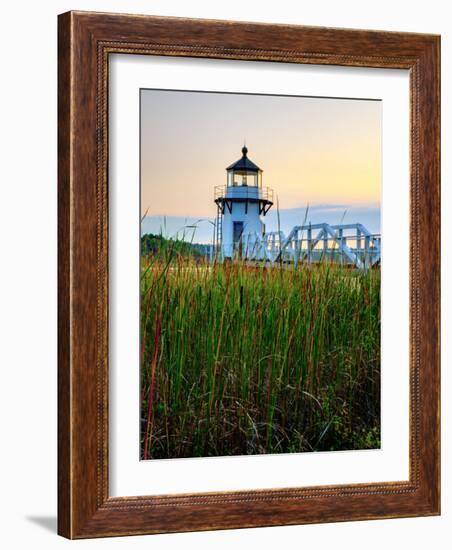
[{"left": 58, "top": 12, "right": 440, "bottom": 538}]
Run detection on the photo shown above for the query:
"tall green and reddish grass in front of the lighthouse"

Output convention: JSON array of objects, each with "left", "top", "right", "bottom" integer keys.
[{"left": 141, "top": 242, "right": 380, "bottom": 459}]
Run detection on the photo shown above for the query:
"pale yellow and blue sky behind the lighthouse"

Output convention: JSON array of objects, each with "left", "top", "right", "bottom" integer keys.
[{"left": 141, "top": 90, "right": 381, "bottom": 242}]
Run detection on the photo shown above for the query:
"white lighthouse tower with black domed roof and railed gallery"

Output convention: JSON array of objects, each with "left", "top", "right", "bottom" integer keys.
[{"left": 215, "top": 146, "right": 273, "bottom": 259}]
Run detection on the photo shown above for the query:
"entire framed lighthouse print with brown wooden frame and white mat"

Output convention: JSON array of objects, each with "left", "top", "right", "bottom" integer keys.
[{"left": 58, "top": 12, "right": 440, "bottom": 538}]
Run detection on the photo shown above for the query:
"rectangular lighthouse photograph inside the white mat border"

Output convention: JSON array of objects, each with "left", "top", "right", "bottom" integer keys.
[{"left": 140, "top": 89, "right": 381, "bottom": 460}]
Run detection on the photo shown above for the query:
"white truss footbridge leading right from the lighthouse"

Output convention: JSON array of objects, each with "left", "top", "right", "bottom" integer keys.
[{"left": 211, "top": 223, "right": 381, "bottom": 269}]
